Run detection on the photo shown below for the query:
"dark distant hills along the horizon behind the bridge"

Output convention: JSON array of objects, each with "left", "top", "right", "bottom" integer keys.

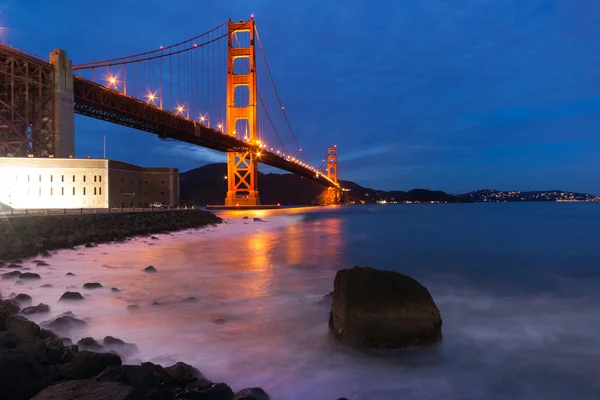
[{"left": 180, "top": 163, "right": 600, "bottom": 205}]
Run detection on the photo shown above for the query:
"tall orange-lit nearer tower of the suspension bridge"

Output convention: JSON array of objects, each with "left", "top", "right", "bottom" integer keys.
[{"left": 225, "top": 19, "right": 261, "bottom": 206}]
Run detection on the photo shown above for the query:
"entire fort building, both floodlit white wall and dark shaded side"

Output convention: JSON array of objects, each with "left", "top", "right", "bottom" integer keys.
[{"left": 0, "top": 157, "right": 179, "bottom": 209}]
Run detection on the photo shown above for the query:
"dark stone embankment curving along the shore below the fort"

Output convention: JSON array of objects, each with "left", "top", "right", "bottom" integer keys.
[{"left": 0, "top": 210, "right": 222, "bottom": 259}]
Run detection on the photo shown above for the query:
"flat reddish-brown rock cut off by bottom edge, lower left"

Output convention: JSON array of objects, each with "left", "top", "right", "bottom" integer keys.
[{"left": 32, "top": 379, "right": 135, "bottom": 400}]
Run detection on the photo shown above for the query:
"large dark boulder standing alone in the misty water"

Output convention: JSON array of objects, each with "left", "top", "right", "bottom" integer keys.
[{"left": 329, "top": 267, "right": 442, "bottom": 348}]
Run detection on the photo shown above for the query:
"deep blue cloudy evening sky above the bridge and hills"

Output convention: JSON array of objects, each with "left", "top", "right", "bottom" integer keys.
[{"left": 0, "top": 0, "right": 600, "bottom": 194}]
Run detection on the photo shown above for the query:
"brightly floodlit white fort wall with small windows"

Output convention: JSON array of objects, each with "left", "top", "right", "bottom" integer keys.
[{"left": 0, "top": 157, "right": 108, "bottom": 208}]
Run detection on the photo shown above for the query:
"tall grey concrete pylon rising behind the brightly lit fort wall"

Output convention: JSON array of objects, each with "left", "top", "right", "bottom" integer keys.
[{"left": 50, "top": 49, "right": 75, "bottom": 158}]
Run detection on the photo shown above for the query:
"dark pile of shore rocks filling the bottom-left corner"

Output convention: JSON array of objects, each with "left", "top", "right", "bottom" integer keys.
[{"left": 0, "top": 300, "right": 269, "bottom": 400}]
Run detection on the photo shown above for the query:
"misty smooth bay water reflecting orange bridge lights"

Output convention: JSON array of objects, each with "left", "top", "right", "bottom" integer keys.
[{"left": 0, "top": 203, "right": 600, "bottom": 400}]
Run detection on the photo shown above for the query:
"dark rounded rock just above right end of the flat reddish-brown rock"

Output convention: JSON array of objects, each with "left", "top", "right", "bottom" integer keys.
[{"left": 95, "top": 362, "right": 176, "bottom": 391}]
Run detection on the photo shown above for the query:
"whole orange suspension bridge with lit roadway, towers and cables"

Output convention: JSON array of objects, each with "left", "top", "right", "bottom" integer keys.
[{"left": 0, "top": 18, "right": 341, "bottom": 206}]
